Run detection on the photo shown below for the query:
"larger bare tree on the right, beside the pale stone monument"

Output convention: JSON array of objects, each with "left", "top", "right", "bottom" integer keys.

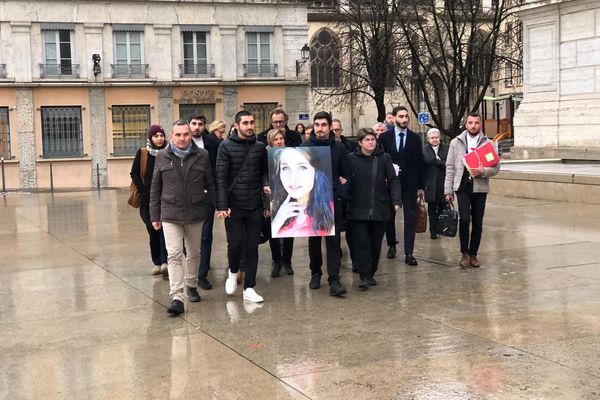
[{"left": 393, "top": 0, "right": 514, "bottom": 137}]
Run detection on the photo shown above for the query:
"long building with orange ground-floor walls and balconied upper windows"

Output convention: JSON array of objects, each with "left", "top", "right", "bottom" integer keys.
[{"left": 0, "top": 0, "right": 308, "bottom": 189}]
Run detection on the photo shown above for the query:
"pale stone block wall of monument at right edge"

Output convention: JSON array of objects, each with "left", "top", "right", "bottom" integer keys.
[{"left": 513, "top": 0, "right": 600, "bottom": 160}]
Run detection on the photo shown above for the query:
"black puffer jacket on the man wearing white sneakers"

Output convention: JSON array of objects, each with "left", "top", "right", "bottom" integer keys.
[{"left": 216, "top": 132, "right": 269, "bottom": 211}]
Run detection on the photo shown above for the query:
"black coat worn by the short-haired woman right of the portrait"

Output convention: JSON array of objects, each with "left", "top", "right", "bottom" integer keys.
[{"left": 346, "top": 146, "right": 402, "bottom": 221}]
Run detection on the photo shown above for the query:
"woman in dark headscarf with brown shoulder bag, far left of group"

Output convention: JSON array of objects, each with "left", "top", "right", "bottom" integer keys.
[{"left": 130, "top": 125, "right": 169, "bottom": 278}]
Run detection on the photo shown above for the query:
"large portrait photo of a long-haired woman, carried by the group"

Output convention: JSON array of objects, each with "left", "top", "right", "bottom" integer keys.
[{"left": 269, "top": 146, "right": 335, "bottom": 238}]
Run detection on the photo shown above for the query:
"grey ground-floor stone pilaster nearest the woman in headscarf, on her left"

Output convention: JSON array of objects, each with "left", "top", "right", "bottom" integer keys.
[{"left": 89, "top": 87, "right": 110, "bottom": 188}]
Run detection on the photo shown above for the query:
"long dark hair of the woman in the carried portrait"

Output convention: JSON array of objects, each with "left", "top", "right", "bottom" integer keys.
[{"left": 271, "top": 148, "right": 335, "bottom": 233}]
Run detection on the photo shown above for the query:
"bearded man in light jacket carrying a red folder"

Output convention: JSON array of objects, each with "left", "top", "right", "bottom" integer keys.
[{"left": 444, "top": 113, "right": 500, "bottom": 268}]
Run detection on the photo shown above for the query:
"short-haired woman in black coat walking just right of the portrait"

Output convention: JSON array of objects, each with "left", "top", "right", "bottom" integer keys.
[{"left": 345, "top": 129, "right": 401, "bottom": 290}]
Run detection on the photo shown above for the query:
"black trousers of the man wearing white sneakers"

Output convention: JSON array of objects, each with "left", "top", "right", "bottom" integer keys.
[{"left": 225, "top": 208, "right": 263, "bottom": 289}]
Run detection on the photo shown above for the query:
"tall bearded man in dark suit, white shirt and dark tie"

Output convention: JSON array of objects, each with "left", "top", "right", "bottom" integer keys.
[{"left": 379, "top": 106, "right": 425, "bottom": 265}]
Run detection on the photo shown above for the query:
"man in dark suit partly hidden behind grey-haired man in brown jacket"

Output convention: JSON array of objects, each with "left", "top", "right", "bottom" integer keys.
[{"left": 189, "top": 115, "right": 219, "bottom": 290}]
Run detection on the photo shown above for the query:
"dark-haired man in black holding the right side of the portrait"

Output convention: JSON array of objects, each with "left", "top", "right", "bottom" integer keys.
[{"left": 305, "top": 111, "right": 348, "bottom": 296}]
